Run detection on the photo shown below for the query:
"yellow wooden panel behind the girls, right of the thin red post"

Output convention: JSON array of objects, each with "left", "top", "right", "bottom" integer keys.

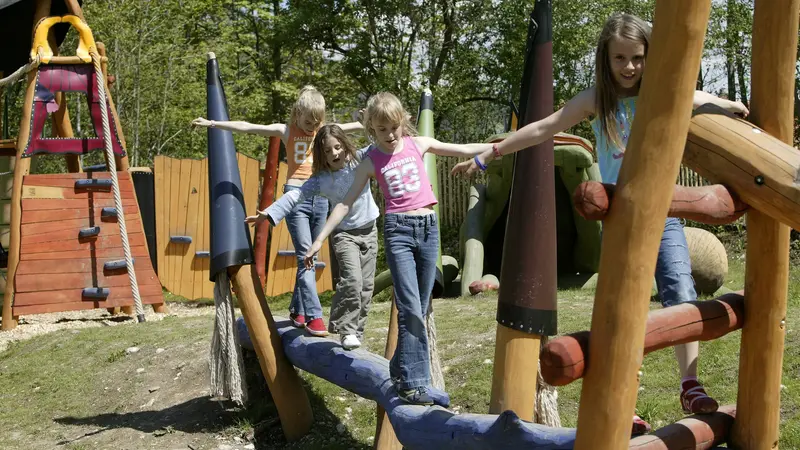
[{"left": 264, "top": 163, "right": 333, "bottom": 297}]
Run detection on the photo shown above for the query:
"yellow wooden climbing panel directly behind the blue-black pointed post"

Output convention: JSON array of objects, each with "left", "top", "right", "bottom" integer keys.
[{"left": 154, "top": 153, "right": 261, "bottom": 300}]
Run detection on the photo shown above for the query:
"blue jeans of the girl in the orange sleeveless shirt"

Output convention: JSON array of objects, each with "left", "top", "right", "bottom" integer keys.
[{"left": 283, "top": 185, "right": 328, "bottom": 320}]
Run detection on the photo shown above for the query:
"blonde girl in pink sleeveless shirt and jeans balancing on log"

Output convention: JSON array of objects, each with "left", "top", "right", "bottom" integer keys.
[{"left": 305, "top": 92, "right": 492, "bottom": 405}]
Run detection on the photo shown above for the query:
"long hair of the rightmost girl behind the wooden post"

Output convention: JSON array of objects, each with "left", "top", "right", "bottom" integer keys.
[{"left": 595, "top": 14, "right": 650, "bottom": 147}]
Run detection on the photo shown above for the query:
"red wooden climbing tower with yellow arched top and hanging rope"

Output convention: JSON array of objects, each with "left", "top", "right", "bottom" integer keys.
[{"left": 0, "top": 0, "right": 165, "bottom": 330}]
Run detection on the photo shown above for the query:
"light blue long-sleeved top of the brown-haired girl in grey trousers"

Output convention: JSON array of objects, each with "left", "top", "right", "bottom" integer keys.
[{"left": 265, "top": 147, "right": 380, "bottom": 231}]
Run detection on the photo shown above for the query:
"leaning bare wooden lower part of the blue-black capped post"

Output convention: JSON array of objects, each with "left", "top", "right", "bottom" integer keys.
[{"left": 228, "top": 265, "right": 314, "bottom": 442}]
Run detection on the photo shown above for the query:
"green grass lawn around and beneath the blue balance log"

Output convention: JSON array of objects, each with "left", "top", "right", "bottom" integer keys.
[{"left": 0, "top": 255, "right": 800, "bottom": 450}]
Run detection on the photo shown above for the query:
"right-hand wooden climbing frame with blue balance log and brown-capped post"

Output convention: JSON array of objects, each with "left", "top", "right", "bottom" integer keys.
[{"left": 227, "top": 0, "right": 800, "bottom": 450}]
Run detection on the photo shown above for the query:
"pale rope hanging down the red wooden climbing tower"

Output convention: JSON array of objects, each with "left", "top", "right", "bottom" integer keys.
[{"left": 91, "top": 52, "right": 144, "bottom": 322}]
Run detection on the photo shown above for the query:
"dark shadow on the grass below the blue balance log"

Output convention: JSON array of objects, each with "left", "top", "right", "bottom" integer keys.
[{"left": 53, "top": 350, "right": 371, "bottom": 450}]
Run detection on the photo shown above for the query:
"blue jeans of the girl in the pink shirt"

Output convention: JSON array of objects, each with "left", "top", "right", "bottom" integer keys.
[{"left": 383, "top": 214, "right": 439, "bottom": 390}]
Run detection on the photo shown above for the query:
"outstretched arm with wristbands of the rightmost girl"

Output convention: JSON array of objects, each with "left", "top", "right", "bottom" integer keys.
[{"left": 452, "top": 87, "right": 594, "bottom": 175}]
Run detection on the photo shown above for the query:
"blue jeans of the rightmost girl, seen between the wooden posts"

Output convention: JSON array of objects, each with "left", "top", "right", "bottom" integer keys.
[{"left": 656, "top": 217, "right": 697, "bottom": 308}]
